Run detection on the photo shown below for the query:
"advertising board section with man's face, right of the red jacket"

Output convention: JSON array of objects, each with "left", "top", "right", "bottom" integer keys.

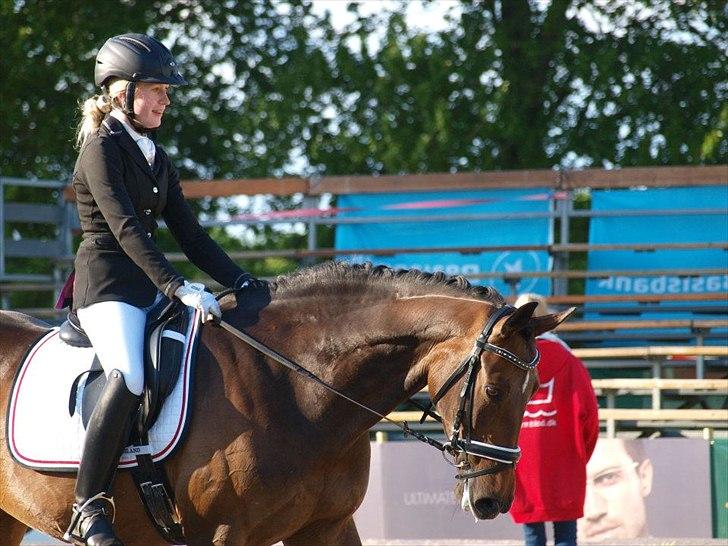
[{"left": 578, "top": 438, "right": 711, "bottom": 542}]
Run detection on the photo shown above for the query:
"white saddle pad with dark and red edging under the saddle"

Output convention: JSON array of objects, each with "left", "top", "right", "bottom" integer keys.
[{"left": 7, "top": 312, "right": 199, "bottom": 471}]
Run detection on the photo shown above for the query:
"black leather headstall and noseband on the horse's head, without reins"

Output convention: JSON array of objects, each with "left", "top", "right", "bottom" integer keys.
[{"left": 423, "top": 305, "right": 540, "bottom": 480}]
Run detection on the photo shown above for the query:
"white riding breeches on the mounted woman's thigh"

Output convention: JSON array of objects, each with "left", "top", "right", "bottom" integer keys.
[{"left": 76, "top": 301, "right": 147, "bottom": 395}]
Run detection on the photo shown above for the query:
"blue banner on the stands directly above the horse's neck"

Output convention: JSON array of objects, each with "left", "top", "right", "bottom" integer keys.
[{"left": 335, "top": 189, "right": 552, "bottom": 295}]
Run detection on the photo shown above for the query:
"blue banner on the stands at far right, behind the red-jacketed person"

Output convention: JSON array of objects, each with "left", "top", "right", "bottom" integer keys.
[{"left": 586, "top": 186, "right": 728, "bottom": 318}]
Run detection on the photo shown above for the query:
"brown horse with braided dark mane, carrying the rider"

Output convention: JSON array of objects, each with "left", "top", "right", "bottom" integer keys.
[{"left": 0, "top": 264, "right": 570, "bottom": 546}]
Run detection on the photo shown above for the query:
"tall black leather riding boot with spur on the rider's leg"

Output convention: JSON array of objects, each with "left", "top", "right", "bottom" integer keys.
[{"left": 63, "top": 370, "right": 139, "bottom": 546}]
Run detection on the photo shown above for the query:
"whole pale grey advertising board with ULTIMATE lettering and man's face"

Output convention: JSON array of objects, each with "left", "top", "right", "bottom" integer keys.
[{"left": 356, "top": 438, "right": 712, "bottom": 544}]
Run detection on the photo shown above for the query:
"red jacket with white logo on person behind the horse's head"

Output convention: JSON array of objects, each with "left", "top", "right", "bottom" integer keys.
[{"left": 511, "top": 337, "right": 599, "bottom": 523}]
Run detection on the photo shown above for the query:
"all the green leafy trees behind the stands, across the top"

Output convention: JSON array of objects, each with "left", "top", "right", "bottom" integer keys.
[{"left": 0, "top": 0, "right": 728, "bottom": 294}]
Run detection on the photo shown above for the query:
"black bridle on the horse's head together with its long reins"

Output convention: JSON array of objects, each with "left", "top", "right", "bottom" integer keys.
[{"left": 217, "top": 290, "right": 539, "bottom": 480}]
